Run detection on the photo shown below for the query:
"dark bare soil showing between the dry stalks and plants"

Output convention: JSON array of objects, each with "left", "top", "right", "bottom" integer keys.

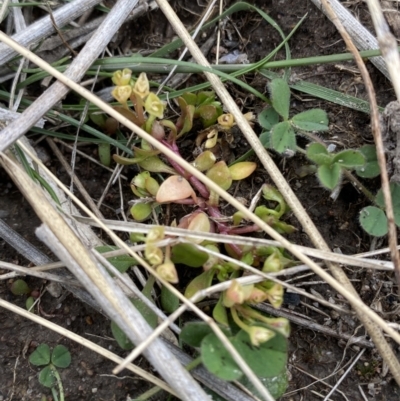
[{"left": 0, "top": 0, "right": 400, "bottom": 401}]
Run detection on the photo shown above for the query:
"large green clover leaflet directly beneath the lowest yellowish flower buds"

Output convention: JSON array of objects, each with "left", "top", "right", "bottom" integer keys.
[{"left": 232, "top": 323, "right": 287, "bottom": 377}]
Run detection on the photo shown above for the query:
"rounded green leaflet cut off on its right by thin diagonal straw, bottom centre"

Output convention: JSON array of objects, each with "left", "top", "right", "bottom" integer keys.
[{"left": 201, "top": 333, "right": 242, "bottom": 381}]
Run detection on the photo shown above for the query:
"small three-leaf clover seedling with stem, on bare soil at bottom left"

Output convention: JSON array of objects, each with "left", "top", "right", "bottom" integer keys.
[{"left": 29, "top": 344, "right": 71, "bottom": 401}]
